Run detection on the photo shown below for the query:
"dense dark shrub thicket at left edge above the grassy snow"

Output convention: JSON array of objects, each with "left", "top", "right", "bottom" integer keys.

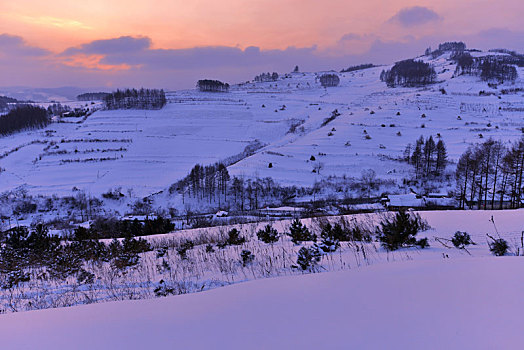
[{"left": 0, "top": 224, "right": 151, "bottom": 289}]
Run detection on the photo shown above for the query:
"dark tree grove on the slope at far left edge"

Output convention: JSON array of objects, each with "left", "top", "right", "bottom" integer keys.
[{"left": 0, "top": 105, "right": 51, "bottom": 135}]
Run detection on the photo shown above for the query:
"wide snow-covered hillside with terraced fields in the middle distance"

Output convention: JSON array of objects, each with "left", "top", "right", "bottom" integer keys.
[{"left": 0, "top": 49, "right": 524, "bottom": 196}]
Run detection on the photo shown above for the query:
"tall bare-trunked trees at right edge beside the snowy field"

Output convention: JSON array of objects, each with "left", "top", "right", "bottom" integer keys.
[{"left": 455, "top": 137, "right": 524, "bottom": 209}]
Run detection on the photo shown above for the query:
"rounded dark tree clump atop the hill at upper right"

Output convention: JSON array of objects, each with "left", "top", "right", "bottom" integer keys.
[{"left": 380, "top": 59, "right": 437, "bottom": 87}]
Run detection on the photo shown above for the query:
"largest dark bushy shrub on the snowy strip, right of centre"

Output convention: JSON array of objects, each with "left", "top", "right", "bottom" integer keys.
[{"left": 378, "top": 211, "right": 429, "bottom": 251}]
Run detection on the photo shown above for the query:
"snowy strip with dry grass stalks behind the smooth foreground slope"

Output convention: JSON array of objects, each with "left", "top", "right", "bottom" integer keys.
[{"left": 0, "top": 210, "right": 524, "bottom": 318}]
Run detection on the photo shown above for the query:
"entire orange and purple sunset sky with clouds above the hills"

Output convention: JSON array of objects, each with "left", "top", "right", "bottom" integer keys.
[{"left": 0, "top": 0, "right": 524, "bottom": 90}]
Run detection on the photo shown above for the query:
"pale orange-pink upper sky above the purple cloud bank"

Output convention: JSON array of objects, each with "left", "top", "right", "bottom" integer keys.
[{"left": 0, "top": 0, "right": 524, "bottom": 52}]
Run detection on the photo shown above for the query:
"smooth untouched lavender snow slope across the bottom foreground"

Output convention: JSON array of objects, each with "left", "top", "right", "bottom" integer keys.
[{"left": 0, "top": 257, "right": 524, "bottom": 349}]
